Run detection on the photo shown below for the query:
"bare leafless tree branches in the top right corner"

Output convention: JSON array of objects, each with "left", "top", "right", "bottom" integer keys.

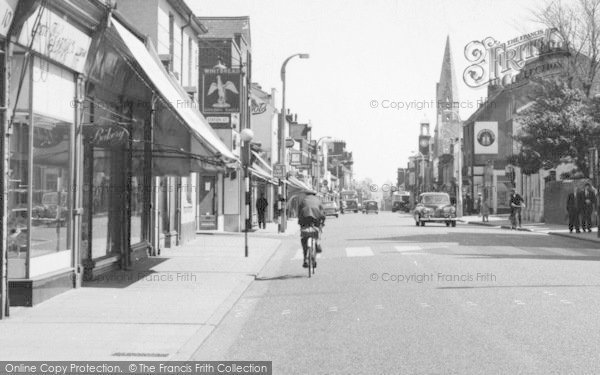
[{"left": 534, "top": 0, "right": 600, "bottom": 98}]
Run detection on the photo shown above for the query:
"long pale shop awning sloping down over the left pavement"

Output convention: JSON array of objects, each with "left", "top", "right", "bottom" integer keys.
[{"left": 111, "top": 18, "right": 237, "bottom": 162}]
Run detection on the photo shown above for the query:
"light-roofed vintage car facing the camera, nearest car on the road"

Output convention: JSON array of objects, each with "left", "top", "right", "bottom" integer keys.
[{"left": 414, "top": 192, "right": 456, "bottom": 227}]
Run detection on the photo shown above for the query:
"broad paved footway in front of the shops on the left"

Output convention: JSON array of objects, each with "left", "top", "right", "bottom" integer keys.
[{"left": 0, "top": 221, "right": 296, "bottom": 360}]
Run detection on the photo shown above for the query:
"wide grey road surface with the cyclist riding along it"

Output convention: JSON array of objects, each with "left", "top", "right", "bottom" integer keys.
[{"left": 194, "top": 212, "right": 600, "bottom": 374}]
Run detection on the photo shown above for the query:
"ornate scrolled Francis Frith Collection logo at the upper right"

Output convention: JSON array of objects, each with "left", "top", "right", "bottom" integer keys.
[{"left": 463, "top": 29, "right": 563, "bottom": 88}]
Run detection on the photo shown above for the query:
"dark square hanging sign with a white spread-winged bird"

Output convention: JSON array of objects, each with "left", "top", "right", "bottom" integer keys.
[{"left": 202, "top": 69, "right": 242, "bottom": 114}]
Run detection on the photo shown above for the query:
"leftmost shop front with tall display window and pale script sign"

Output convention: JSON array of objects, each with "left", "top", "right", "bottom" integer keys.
[{"left": 6, "top": 3, "right": 91, "bottom": 306}]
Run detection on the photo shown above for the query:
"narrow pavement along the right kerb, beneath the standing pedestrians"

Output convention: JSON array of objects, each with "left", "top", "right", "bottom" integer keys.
[{"left": 459, "top": 215, "right": 600, "bottom": 243}]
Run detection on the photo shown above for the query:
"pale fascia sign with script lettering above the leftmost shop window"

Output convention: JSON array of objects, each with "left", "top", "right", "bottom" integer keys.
[{"left": 19, "top": 7, "right": 92, "bottom": 72}]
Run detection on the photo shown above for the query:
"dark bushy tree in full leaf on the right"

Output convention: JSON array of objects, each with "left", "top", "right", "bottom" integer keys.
[{"left": 509, "top": 79, "right": 600, "bottom": 176}]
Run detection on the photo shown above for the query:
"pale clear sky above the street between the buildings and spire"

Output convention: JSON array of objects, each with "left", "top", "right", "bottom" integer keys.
[{"left": 186, "top": 0, "right": 545, "bottom": 184}]
